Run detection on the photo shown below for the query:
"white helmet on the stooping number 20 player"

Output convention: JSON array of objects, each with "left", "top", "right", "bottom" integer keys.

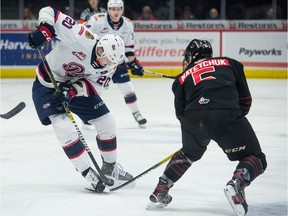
[{"left": 96, "top": 34, "right": 125, "bottom": 64}]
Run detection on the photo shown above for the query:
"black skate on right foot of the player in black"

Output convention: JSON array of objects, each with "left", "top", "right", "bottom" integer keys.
[{"left": 224, "top": 177, "right": 248, "bottom": 216}]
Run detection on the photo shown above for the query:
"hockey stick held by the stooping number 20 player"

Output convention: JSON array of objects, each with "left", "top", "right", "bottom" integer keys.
[{"left": 37, "top": 47, "right": 114, "bottom": 186}]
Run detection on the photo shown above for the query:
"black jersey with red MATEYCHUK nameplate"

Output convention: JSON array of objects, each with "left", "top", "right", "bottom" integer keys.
[{"left": 172, "top": 57, "right": 252, "bottom": 118}]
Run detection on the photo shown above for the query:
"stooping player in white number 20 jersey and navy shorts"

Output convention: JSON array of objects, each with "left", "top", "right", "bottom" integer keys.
[{"left": 28, "top": 7, "right": 133, "bottom": 192}]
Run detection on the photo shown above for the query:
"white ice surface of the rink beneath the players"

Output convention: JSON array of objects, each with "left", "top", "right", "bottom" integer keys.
[{"left": 0, "top": 79, "right": 287, "bottom": 216}]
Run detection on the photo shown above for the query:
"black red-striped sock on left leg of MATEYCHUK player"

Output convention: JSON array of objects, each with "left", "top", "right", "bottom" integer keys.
[{"left": 164, "top": 151, "right": 192, "bottom": 183}]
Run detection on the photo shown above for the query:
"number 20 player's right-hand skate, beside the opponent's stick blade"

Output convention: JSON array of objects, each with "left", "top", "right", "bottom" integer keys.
[{"left": 101, "top": 161, "right": 135, "bottom": 188}]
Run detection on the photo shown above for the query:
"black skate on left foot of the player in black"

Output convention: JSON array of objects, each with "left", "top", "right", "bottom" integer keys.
[{"left": 146, "top": 177, "right": 173, "bottom": 210}]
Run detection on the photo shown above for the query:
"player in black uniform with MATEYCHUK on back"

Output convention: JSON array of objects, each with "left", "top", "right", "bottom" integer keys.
[{"left": 148, "top": 39, "right": 267, "bottom": 216}]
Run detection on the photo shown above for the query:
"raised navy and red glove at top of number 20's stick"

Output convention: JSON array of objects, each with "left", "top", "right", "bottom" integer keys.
[{"left": 28, "top": 23, "right": 56, "bottom": 49}]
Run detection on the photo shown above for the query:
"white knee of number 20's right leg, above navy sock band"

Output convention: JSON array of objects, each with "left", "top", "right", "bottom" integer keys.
[{"left": 88, "top": 113, "right": 116, "bottom": 139}]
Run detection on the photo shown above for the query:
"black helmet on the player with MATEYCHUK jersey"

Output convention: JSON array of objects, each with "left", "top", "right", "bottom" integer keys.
[{"left": 183, "top": 39, "right": 213, "bottom": 65}]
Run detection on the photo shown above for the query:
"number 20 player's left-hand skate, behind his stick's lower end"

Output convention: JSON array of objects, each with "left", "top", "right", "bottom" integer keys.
[{"left": 82, "top": 167, "right": 105, "bottom": 193}]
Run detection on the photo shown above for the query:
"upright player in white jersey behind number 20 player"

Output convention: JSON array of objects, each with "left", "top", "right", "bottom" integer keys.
[{"left": 84, "top": 0, "right": 147, "bottom": 128}]
